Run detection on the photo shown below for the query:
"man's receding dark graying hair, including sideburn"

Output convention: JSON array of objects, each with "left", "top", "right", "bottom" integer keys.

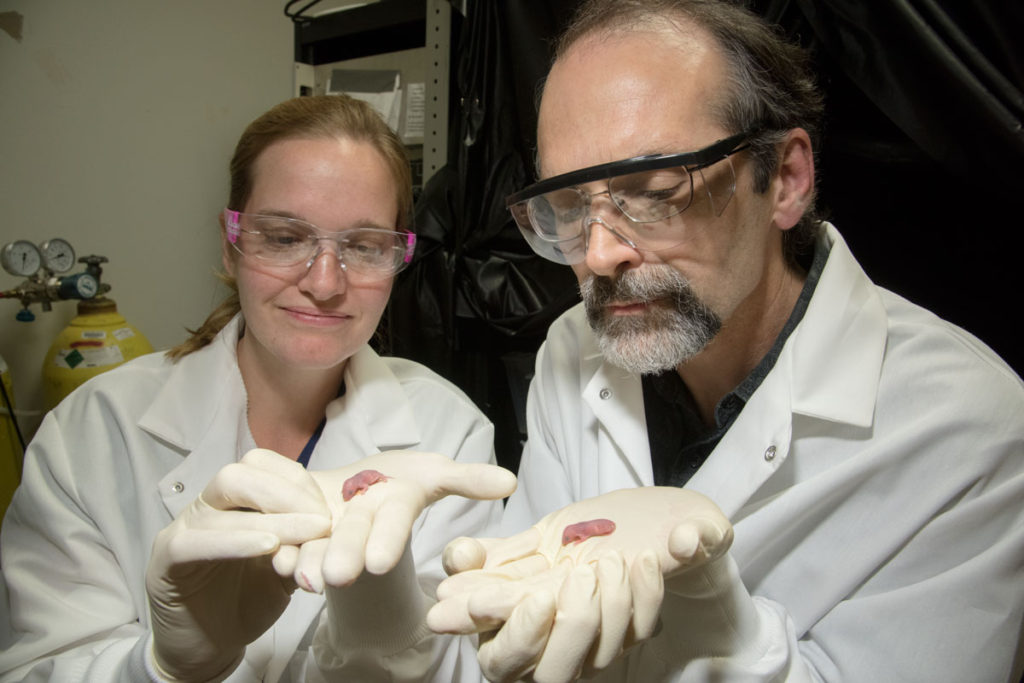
[{"left": 554, "top": 0, "right": 823, "bottom": 264}]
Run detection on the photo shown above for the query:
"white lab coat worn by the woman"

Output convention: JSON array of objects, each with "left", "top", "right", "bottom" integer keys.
[{"left": 0, "top": 316, "right": 501, "bottom": 683}]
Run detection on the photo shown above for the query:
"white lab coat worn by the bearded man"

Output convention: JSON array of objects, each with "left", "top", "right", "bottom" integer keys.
[{"left": 503, "top": 225, "right": 1024, "bottom": 683}]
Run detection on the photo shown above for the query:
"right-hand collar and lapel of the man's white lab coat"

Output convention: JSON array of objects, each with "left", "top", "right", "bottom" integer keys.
[{"left": 686, "top": 223, "right": 888, "bottom": 511}]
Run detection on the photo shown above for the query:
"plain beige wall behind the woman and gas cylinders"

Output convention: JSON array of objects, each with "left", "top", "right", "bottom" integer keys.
[{"left": 0, "top": 0, "right": 294, "bottom": 434}]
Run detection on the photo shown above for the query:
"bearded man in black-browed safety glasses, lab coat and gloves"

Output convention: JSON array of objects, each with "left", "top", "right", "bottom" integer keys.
[{"left": 431, "top": 0, "right": 1024, "bottom": 682}]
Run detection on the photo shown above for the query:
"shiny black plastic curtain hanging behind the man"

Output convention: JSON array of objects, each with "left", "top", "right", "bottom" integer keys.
[{"left": 388, "top": 0, "right": 1024, "bottom": 470}]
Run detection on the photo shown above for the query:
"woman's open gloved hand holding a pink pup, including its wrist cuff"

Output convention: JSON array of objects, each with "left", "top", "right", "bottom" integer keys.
[{"left": 274, "top": 451, "right": 516, "bottom": 680}]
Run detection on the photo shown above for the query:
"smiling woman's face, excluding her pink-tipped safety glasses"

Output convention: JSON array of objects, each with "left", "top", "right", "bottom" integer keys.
[{"left": 222, "top": 138, "right": 398, "bottom": 371}]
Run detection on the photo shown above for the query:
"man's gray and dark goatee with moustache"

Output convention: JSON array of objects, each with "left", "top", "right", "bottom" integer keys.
[{"left": 580, "top": 265, "right": 722, "bottom": 375}]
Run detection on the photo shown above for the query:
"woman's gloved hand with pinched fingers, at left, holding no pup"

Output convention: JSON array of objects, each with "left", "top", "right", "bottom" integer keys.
[{"left": 145, "top": 450, "right": 331, "bottom": 681}]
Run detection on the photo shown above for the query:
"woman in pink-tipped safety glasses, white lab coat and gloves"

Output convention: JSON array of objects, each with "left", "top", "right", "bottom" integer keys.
[{"left": 0, "top": 96, "right": 514, "bottom": 681}]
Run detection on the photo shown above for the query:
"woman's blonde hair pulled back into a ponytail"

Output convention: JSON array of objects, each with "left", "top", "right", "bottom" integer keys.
[{"left": 167, "top": 95, "right": 413, "bottom": 360}]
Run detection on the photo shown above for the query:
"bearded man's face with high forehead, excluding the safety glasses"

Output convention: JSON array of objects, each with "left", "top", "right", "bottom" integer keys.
[{"left": 538, "top": 25, "right": 781, "bottom": 373}]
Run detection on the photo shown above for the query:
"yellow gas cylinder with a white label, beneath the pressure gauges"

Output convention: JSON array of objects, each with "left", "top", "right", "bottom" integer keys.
[{"left": 43, "top": 297, "right": 153, "bottom": 410}]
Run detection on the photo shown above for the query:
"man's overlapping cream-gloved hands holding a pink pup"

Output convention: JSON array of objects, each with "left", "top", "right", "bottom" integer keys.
[{"left": 427, "top": 486, "right": 732, "bottom": 681}]
